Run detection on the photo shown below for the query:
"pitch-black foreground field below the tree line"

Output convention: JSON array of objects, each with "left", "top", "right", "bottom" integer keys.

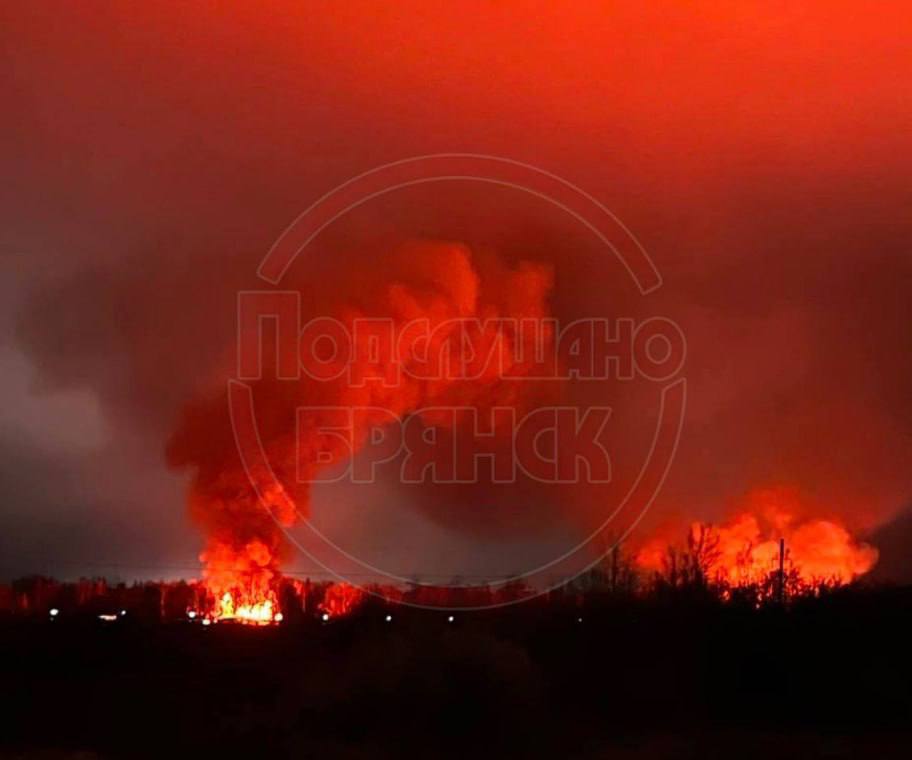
[{"left": 0, "top": 589, "right": 912, "bottom": 758}]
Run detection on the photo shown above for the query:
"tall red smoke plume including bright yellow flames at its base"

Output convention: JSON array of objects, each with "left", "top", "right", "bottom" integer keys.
[{"left": 169, "top": 243, "right": 552, "bottom": 620}]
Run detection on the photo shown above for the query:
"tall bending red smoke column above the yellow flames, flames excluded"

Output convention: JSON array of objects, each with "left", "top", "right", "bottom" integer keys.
[{"left": 169, "top": 242, "right": 551, "bottom": 599}]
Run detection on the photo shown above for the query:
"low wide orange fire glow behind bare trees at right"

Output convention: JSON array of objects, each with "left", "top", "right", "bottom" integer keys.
[{"left": 636, "top": 489, "right": 878, "bottom": 588}]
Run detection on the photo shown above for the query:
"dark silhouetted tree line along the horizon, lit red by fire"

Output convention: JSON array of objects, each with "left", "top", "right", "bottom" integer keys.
[{"left": 0, "top": 526, "right": 868, "bottom": 623}]
